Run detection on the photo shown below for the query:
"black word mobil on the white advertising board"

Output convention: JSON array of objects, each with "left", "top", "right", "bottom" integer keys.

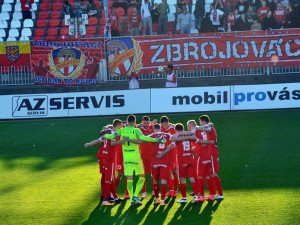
[{"left": 172, "top": 91, "right": 228, "bottom": 105}]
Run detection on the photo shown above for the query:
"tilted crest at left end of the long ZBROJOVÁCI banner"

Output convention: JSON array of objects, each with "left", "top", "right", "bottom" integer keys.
[{"left": 107, "top": 38, "right": 143, "bottom": 77}]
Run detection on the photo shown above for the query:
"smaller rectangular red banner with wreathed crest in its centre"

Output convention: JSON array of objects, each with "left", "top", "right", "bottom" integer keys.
[{"left": 32, "top": 40, "right": 103, "bottom": 86}]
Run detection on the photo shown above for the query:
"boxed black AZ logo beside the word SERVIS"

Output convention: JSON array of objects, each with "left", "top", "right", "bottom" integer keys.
[{"left": 12, "top": 95, "right": 48, "bottom": 117}]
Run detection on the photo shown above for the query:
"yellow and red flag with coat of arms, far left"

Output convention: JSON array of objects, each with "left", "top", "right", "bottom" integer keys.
[{"left": 0, "top": 41, "right": 31, "bottom": 66}]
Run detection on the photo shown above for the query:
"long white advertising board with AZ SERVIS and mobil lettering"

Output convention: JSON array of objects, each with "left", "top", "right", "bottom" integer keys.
[{"left": 0, "top": 83, "right": 300, "bottom": 120}]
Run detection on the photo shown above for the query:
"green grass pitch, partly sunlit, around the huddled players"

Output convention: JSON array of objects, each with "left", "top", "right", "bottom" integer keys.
[{"left": 0, "top": 110, "right": 300, "bottom": 225}]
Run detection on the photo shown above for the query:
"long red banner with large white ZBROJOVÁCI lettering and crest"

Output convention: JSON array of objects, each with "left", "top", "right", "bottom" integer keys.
[{"left": 106, "top": 29, "right": 300, "bottom": 76}]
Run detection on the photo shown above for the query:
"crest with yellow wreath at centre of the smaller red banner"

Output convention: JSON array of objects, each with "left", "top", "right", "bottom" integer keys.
[{"left": 48, "top": 48, "right": 84, "bottom": 79}]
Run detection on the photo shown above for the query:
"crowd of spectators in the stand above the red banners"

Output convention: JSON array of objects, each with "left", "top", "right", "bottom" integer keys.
[{"left": 62, "top": 0, "right": 300, "bottom": 36}]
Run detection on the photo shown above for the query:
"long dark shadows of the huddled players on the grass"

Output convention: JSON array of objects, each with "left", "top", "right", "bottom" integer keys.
[{"left": 82, "top": 197, "right": 221, "bottom": 225}]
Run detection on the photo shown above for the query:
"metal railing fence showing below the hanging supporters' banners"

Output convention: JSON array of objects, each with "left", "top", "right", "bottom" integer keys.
[{"left": 0, "top": 64, "right": 300, "bottom": 85}]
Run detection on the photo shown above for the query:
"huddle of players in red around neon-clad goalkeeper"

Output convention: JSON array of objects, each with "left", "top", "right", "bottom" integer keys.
[{"left": 85, "top": 115, "right": 224, "bottom": 206}]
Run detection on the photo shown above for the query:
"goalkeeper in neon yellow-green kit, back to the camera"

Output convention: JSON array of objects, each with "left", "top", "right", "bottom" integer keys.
[{"left": 104, "top": 115, "right": 166, "bottom": 205}]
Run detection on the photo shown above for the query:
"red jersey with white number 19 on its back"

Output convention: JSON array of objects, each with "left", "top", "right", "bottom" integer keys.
[{"left": 176, "top": 140, "right": 194, "bottom": 165}]
